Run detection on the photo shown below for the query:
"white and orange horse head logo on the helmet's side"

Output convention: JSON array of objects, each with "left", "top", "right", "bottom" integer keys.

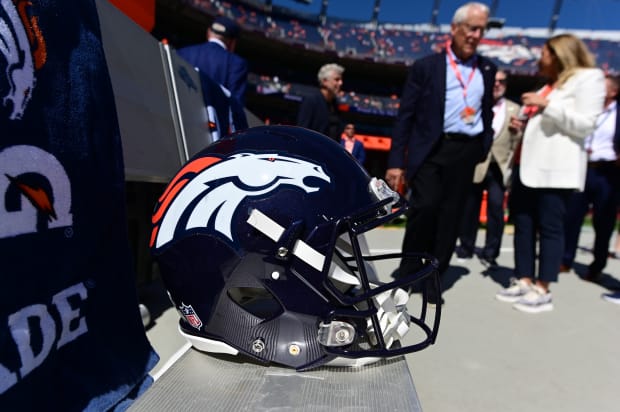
[{"left": 150, "top": 153, "right": 331, "bottom": 248}]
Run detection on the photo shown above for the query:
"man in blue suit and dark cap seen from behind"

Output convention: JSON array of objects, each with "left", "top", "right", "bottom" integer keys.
[{"left": 178, "top": 16, "right": 248, "bottom": 107}]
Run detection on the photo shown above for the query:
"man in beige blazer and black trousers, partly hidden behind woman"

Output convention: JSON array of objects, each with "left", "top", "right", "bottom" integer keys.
[{"left": 456, "top": 70, "right": 521, "bottom": 268}]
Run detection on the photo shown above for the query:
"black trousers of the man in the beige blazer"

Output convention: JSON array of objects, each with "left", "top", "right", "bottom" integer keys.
[{"left": 459, "top": 162, "right": 506, "bottom": 259}]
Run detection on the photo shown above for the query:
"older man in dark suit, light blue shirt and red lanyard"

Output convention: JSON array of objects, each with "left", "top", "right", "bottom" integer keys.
[{"left": 386, "top": 3, "right": 497, "bottom": 302}]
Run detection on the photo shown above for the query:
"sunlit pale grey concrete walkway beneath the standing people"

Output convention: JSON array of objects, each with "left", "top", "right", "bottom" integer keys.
[{"left": 147, "top": 228, "right": 620, "bottom": 412}]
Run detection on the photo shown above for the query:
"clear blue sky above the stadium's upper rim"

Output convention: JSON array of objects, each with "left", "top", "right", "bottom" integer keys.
[{"left": 272, "top": 0, "right": 620, "bottom": 30}]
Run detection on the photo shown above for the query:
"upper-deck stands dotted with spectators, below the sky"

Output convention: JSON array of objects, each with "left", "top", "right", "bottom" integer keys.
[{"left": 191, "top": 0, "right": 620, "bottom": 75}]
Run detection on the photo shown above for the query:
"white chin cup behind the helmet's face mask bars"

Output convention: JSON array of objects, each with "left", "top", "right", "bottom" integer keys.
[{"left": 367, "top": 288, "right": 410, "bottom": 349}]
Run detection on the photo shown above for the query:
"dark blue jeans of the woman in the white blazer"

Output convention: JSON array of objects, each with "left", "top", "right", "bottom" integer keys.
[{"left": 510, "top": 167, "right": 573, "bottom": 282}]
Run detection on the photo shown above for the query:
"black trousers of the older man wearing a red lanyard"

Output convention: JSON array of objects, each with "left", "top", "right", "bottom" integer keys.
[{"left": 399, "top": 137, "right": 482, "bottom": 275}]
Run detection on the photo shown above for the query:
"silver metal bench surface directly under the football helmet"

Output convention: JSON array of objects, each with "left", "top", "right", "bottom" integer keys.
[{"left": 129, "top": 349, "right": 421, "bottom": 412}]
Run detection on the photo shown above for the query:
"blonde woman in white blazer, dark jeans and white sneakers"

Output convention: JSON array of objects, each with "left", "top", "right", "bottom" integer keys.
[{"left": 496, "top": 34, "right": 605, "bottom": 313}]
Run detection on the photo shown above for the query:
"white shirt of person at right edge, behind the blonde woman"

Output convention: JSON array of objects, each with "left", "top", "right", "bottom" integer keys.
[{"left": 584, "top": 101, "right": 617, "bottom": 162}]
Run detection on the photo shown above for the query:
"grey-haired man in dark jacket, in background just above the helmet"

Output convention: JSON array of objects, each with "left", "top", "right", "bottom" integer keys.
[{"left": 297, "top": 63, "right": 344, "bottom": 143}]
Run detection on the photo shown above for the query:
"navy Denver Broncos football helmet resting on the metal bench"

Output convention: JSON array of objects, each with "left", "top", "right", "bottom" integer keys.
[{"left": 150, "top": 126, "right": 441, "bottom": 370}]
